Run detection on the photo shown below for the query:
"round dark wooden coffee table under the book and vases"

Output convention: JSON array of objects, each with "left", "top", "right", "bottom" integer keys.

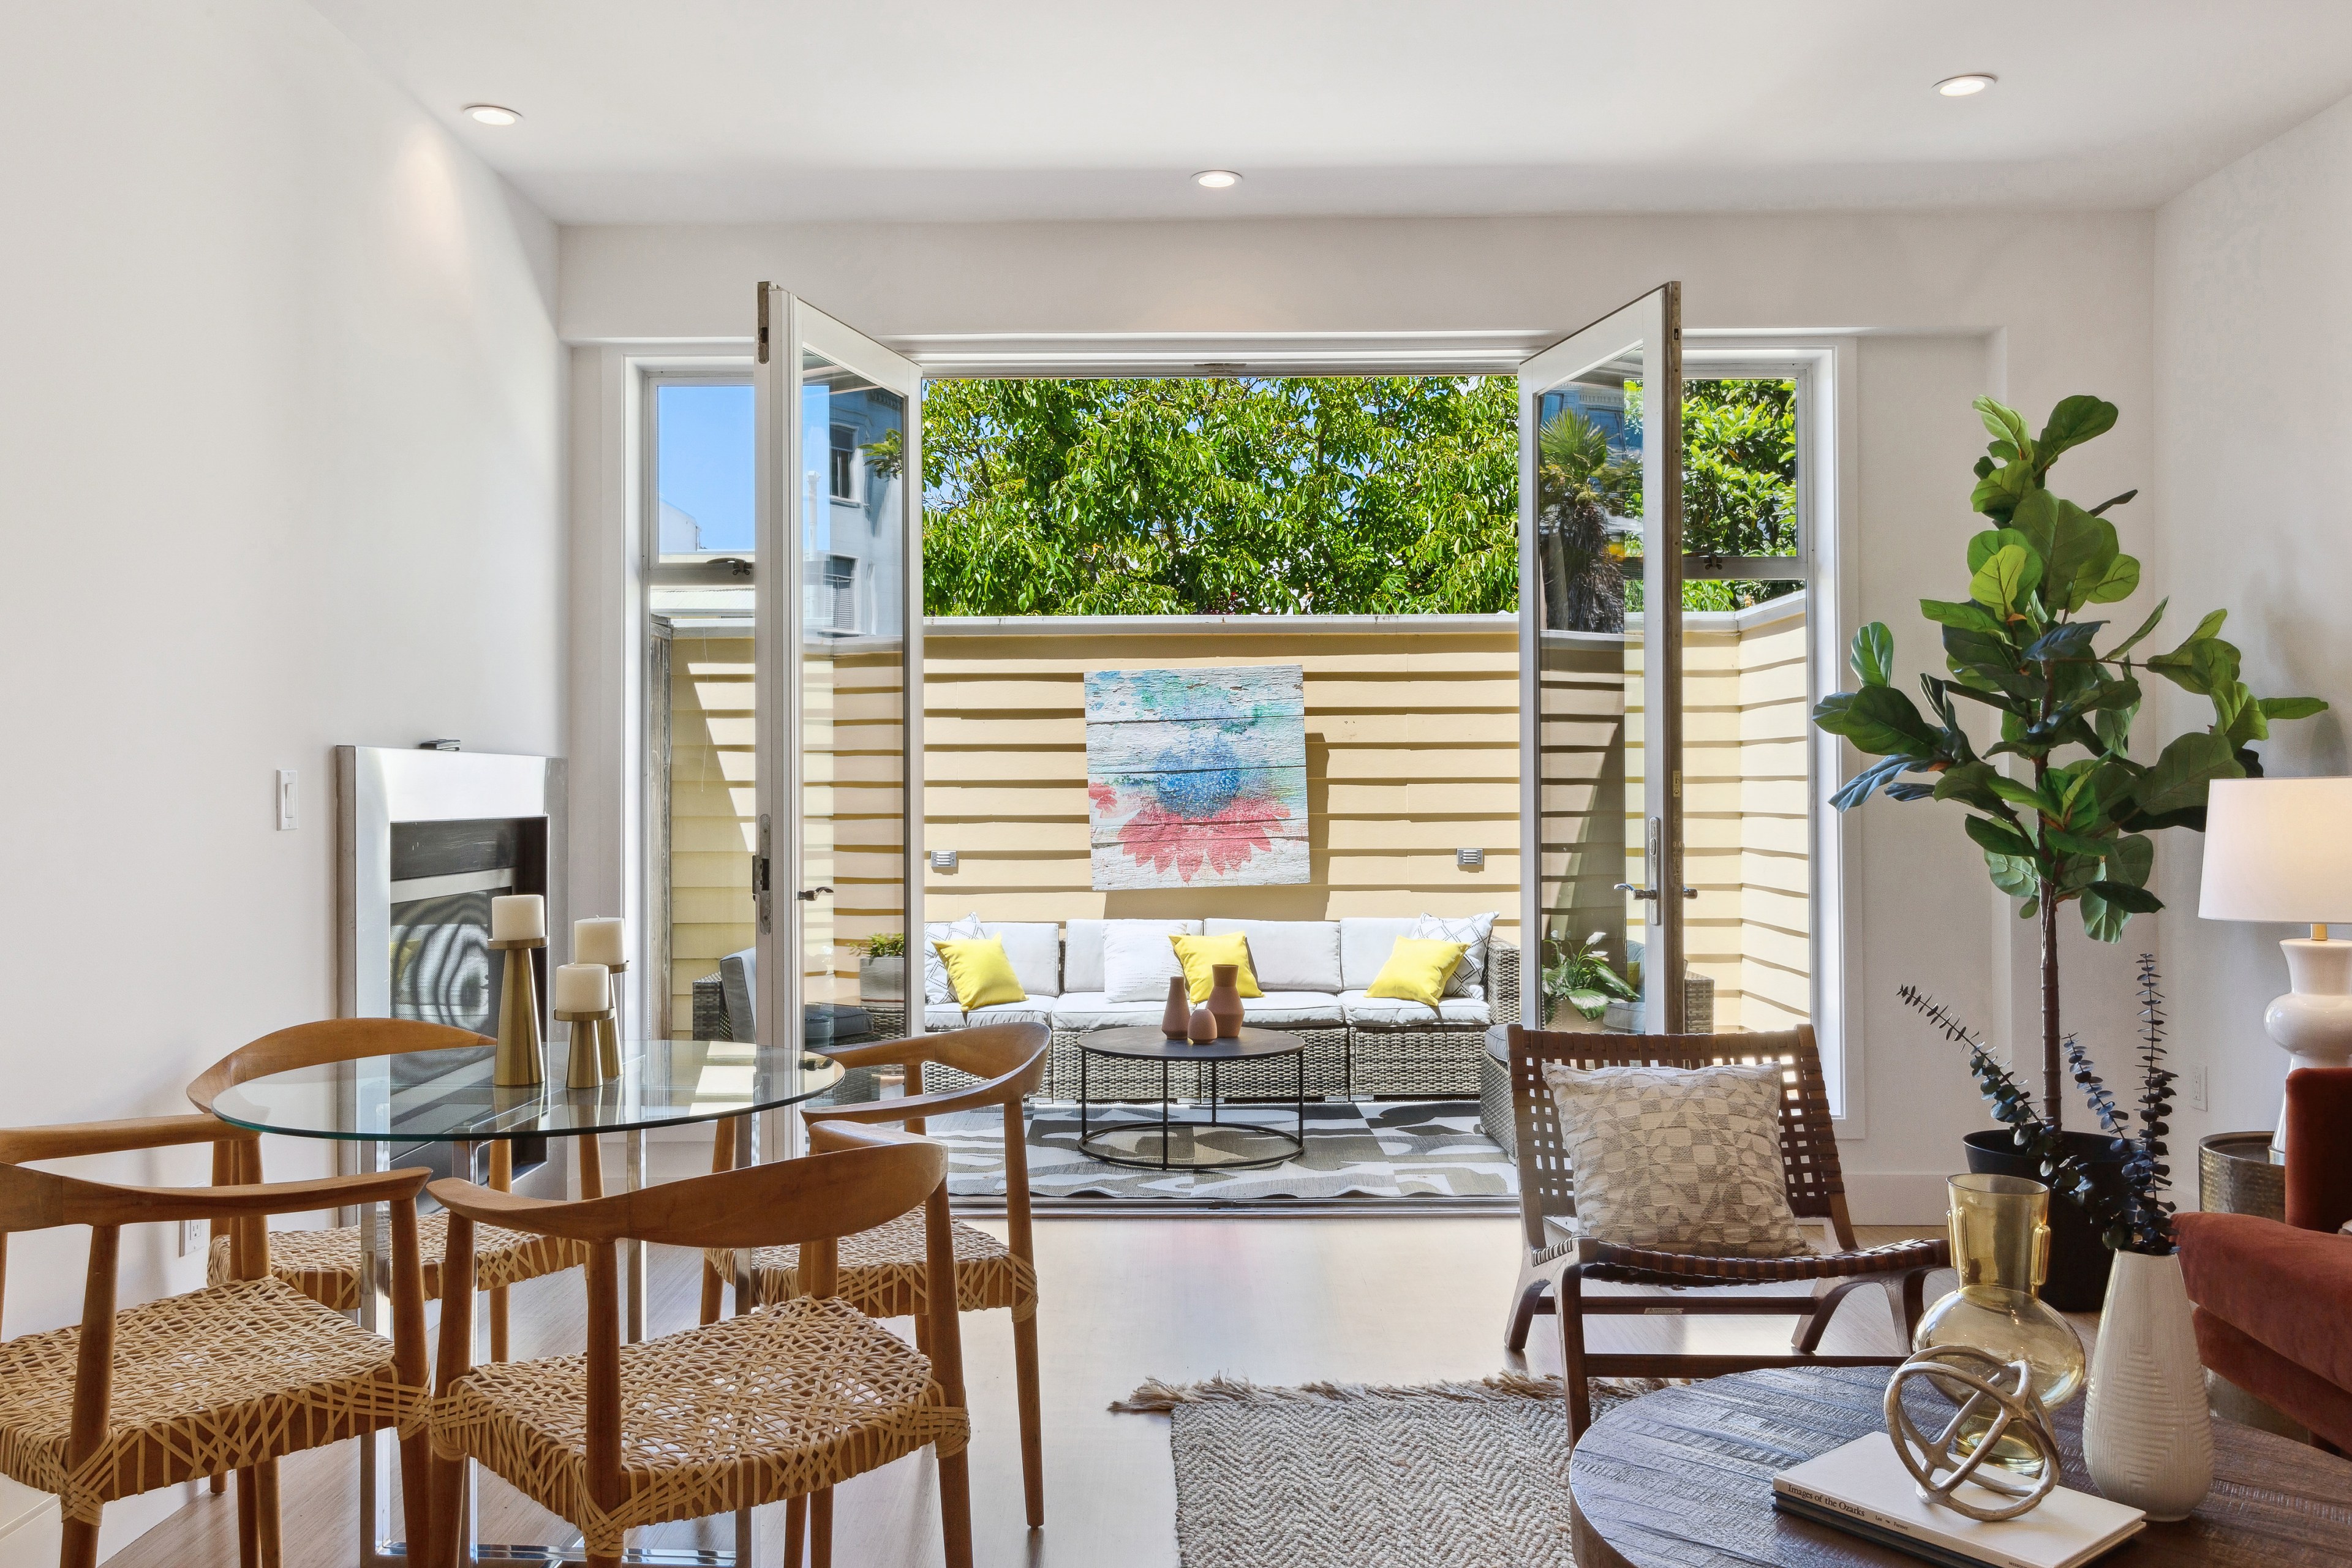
[{"left": 1569, "top": 1366, "right": 2352, "bottom": 1568}]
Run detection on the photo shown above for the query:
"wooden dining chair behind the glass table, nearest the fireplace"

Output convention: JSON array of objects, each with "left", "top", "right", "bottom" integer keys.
[{"left": 188, "top": 1018, "right": 602, "bottom": 1361}]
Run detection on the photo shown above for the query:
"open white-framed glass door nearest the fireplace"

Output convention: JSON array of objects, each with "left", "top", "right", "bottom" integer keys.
[{"left": 753, "top": 284, "right": 922, "bottom": 1049}]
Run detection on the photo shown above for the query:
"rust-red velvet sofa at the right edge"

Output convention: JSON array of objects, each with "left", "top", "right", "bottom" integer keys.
[{"left": 2178, "top": 1067, "right": 2352, "bottom": 1450}]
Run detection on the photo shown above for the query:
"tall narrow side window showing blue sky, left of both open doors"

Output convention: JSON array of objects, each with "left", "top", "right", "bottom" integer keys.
[{"left": 644, "top": 376, "right": 757, "bottom": 1039}]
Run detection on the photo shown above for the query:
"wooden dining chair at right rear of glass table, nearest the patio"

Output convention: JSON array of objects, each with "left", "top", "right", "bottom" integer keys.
[{"left": 703, "top": 1023, "right": 1054, "bottom": 1528}]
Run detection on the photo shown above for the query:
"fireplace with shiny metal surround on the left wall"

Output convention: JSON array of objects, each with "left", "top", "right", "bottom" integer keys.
[{"left": 334, "top": 745, "right": 569, "bottom": 1173}]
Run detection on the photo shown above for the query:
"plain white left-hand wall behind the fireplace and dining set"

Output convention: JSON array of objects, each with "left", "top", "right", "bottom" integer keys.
[{"left": 0, "top": 0, "right": 565, "bottom": 1554}]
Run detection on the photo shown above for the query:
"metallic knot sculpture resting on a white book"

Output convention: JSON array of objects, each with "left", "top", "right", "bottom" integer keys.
[{"left": 1887, "top": 1344, "right": 2058, "bottom": 1518}]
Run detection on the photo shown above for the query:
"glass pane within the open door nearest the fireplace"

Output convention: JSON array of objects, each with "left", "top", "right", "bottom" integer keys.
[{"left": 795, "top": 350, "right": 898, "bottom": 1049}]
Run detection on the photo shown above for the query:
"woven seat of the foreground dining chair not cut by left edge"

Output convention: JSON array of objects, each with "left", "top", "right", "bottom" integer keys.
[{"left": 433, "top": 1298, "right": 971, "bottom": 1556}]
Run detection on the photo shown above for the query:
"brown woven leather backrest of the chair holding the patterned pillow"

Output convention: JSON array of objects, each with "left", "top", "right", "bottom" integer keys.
[{"left": 1510, "top": 1025, "right": 1846, "bottom": 1246}]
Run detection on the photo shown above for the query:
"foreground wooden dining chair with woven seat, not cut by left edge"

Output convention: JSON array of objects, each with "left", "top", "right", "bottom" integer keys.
[{"left": 431, "top": 1126, "right": 971, "bottom": 1568}]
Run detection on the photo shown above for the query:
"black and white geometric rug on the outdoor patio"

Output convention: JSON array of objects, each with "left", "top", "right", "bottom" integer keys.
[{"left": 927, "top": 1100, "right": 1520, "bottom": 1204}]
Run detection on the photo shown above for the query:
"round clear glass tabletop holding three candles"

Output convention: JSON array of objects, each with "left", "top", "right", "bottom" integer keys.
[{"left": 212, "top": 1039, "right": 842, "bottom": 1142}]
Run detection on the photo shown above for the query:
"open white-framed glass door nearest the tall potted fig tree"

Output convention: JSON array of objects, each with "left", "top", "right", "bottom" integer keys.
[{"left": 1520, "top": 282, "right": 1689, "bottom": 1035}]
